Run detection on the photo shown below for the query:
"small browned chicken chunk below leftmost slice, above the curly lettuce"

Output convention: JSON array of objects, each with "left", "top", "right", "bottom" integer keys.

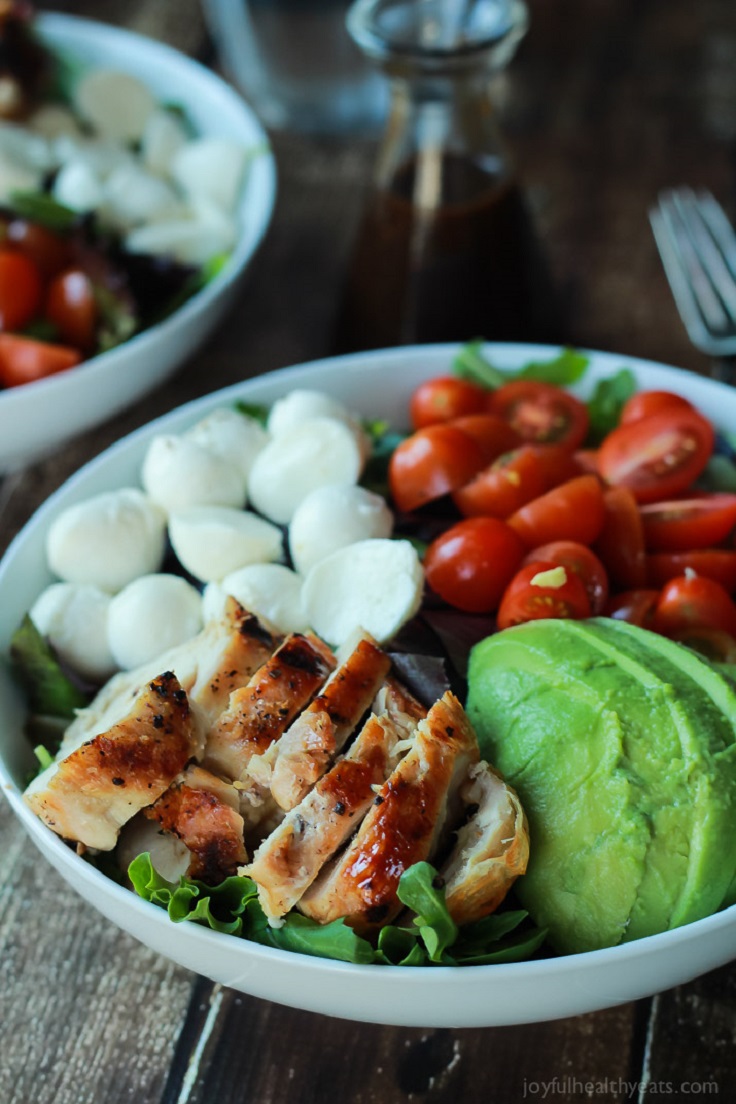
[{"left": 143, "top": 766, "right": 247, "bottom": 885}]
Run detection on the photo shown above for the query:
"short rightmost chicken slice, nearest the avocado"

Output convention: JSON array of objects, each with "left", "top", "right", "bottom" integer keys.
[{"left": 440, "top": 762, "right": 529, "bottom": 924}]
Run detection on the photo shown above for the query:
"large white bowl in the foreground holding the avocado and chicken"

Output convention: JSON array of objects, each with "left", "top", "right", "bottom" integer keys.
[{"left": 0, "top": 346, "right": 736, "bottom": 1027}]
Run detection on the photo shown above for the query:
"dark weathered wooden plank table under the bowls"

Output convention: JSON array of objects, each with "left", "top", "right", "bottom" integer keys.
[{"left": 0, "top": 0, "right": 736, "bottom": 1104}]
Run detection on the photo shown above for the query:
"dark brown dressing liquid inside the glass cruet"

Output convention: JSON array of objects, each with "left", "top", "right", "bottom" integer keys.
[{"left": 335, "top": 155, "right": 566, "bottom": 352}]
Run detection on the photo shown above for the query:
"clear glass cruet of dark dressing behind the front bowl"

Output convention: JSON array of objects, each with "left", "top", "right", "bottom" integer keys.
[{"left": 335, "top": 0, "right": 564, "bottom": 351}]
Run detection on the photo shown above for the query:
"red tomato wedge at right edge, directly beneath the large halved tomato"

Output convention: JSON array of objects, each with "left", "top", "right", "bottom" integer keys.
[{"left": 641, "top": 495, "right": 736, "bottom": 552}]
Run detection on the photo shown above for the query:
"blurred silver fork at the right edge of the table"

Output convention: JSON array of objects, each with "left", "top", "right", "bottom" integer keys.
[{"left": 649, "top": 188, "right": 736, "bottom": 366}]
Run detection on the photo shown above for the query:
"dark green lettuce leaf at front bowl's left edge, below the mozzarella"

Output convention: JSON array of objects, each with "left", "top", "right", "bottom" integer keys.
[{"left": 10, "top": 614, "right": 89, "bottom": 719}]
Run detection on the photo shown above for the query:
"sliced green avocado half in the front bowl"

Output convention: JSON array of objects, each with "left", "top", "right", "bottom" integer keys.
[{"left": 467, "top": 618, "right": 736, "bottom": 953}]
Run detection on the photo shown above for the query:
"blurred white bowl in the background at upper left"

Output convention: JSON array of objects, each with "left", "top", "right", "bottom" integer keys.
[{"left": 0, "top": 14, "right": 276, "bottom": 473}]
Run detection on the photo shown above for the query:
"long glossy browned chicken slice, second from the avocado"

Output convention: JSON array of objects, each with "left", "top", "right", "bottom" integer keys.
[{"left": 298, "top": 691, "right": 478, "bottom": 932}]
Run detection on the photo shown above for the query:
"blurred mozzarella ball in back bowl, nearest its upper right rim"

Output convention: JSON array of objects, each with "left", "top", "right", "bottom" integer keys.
[{"left": 171, "top": 138, "right": 247, "bottom": 213}]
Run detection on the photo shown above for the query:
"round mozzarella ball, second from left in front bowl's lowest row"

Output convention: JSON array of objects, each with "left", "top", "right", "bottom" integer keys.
[{"left": 107, "top": 575, "right": 202, "bottom": 671}]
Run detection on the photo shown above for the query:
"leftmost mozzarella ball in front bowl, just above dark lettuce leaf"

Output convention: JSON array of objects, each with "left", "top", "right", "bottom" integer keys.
[{"left": 31, "top": 583, "right": 116, "bottom": 682}]
